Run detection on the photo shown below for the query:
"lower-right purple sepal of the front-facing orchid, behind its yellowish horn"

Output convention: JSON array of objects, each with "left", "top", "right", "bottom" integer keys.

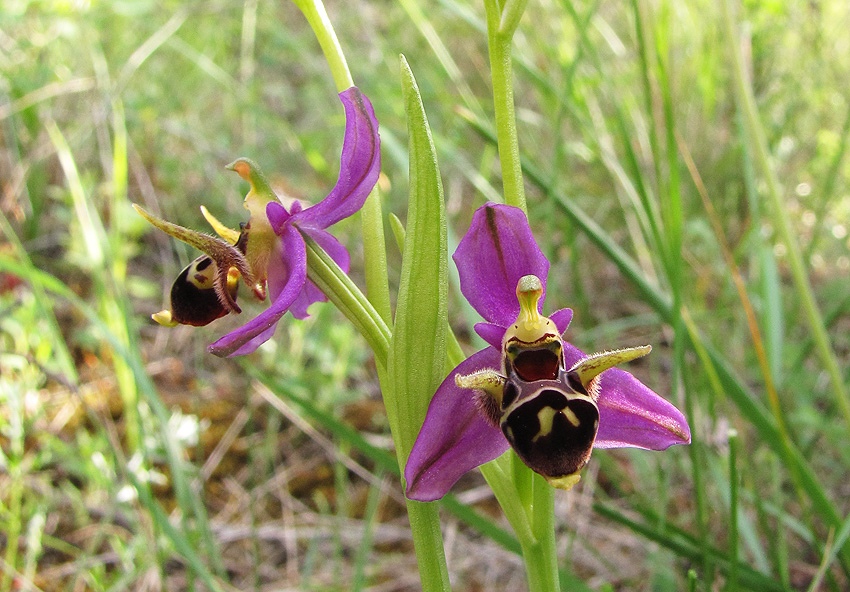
[{"left": 564, "top": 343, "right": 691, "bottom": 450}]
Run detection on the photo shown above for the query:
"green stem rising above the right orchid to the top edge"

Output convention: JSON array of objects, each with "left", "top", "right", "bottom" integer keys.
[{"left": 484, "top": 0, "right": 526, "bottom": 211}]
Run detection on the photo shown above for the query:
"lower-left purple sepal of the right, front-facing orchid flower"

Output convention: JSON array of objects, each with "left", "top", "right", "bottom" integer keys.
[{"left": 404, "top": 347, "right": 508, "bottom": 502}]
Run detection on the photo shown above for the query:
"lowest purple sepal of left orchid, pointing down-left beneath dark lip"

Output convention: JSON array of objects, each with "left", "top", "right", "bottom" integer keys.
[{"left": 208, "top": 225, "right": 307, "bottom": 357}]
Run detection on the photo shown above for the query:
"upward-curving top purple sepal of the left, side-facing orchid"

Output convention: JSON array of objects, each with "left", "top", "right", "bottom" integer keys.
[{"left": 293, "top": 86, "right": 381, "bottom": 228}]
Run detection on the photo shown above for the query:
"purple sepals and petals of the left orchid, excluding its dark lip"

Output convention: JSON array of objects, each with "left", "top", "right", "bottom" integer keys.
[{"left": 209, "top": 86, "right": 381, "bottom": 357}]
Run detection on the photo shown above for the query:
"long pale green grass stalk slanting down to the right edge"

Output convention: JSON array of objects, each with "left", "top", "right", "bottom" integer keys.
[{"left": 722, "top": 0, "right": 850, "bottom": 427}]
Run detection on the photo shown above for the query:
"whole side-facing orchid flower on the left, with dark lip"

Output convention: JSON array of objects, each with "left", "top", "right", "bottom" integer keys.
[{"left": 135, "top": 86, "right": 381, "bottom": 356}]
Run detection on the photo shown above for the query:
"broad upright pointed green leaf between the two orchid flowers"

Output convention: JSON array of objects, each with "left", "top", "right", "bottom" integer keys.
[{"left": 388, "top": 56, "right": 448, "bottom": 467}]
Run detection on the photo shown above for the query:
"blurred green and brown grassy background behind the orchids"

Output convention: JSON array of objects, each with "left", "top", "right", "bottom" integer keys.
[{"left": 0, "top": 0, "right": 850, "bottom": 591}]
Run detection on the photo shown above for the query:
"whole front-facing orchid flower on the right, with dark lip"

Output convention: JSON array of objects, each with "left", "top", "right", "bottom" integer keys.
[{"left": 404, "top": 204, "right": 691, "bottom": 501}]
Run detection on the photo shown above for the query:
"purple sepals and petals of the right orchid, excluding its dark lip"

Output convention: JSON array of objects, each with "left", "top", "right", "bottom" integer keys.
[{"left": 404, "top": 204, "right": 690, "bottom": 501}]
